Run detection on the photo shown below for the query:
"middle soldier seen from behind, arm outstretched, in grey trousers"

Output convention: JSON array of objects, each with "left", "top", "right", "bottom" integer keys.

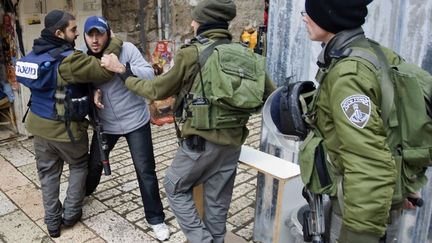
[{"left": 102, "top": 0, "right": 274, "bottom": 243}]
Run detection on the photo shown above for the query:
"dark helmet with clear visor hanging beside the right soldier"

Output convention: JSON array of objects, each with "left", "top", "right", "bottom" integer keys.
[{"left": 270, "top": 81, "right": 316, "bottom": 140}]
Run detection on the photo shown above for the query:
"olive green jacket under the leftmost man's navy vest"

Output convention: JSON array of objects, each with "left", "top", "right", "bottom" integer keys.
[{"left": 25, "top": 38, "right": 123, "bottom": 142}]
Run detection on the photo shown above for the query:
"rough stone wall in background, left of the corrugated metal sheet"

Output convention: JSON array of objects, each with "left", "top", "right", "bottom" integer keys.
[{"left": 102, "top": 0, "right": 264, "bottom": 58}]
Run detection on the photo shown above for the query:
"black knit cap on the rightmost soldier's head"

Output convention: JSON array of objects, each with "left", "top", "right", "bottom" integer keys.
[{"left": 305, "top": 0, "right": 372, "bottom": 34}]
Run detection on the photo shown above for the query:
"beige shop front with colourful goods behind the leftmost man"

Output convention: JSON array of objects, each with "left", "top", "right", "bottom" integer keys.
[{"left": 0, "top": 0, "right": 102, "bottom": 143}]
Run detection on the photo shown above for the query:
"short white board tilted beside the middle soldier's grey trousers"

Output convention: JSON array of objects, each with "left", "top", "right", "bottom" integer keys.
[{"left": 239, "top": 145, "right": 300, "bottom": 180}]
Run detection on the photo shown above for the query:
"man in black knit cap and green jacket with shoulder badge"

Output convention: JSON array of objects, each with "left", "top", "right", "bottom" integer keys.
[{"left": 302, "top": 0, "right": 410, "bottom": 243}]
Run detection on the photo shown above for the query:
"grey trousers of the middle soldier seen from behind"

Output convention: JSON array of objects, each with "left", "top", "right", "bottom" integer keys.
[{"left": 164, "top": 141, "right": 241, "bottom": 243}]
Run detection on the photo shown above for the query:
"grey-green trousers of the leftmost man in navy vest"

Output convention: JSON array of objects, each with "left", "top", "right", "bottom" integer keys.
[{"left": 33, "top": 136, "right": 88, "bottom": 229}]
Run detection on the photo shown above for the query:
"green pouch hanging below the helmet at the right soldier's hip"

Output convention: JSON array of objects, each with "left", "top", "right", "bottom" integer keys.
[{"left": 300, "top": 132, "right": 336, "bottom": 195}]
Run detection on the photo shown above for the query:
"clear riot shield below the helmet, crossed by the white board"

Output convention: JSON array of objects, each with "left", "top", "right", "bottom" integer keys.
[{"left": 253, "top": 88, "right": 307, "bottom": 243}]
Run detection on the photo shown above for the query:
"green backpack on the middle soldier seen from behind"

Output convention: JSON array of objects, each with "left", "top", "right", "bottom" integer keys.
[{"left": 179, "top": 39, "right": 265, "bottom": 130}]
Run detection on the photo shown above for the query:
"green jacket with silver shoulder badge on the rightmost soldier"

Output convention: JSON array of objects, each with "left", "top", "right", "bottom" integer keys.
[{"left": 316, "top": 28, "right": 401, "bottom": 242}]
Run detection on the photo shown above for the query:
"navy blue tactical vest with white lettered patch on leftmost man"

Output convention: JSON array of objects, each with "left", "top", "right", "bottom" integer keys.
[{"left": 15, "top": 48, "right": 89, "bottom": 140}]
